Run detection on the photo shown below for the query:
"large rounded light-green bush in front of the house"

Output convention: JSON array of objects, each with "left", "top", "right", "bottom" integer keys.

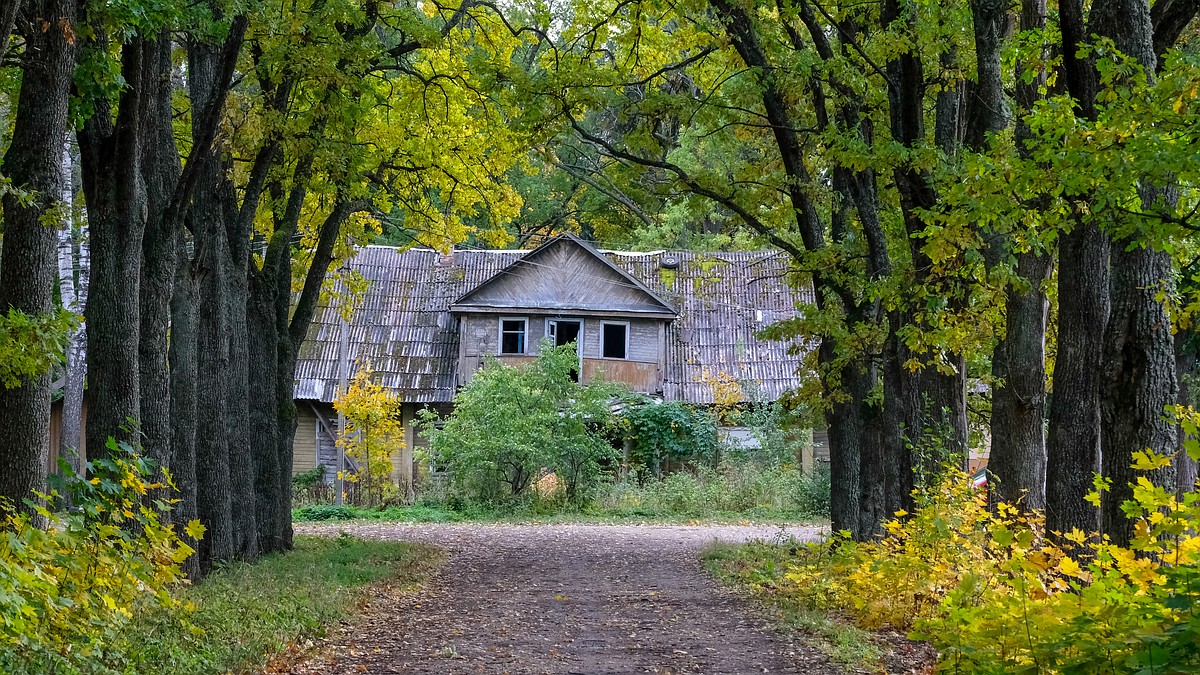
[{"left": 421, "top": 342, "right": 622, "bottom": 508}]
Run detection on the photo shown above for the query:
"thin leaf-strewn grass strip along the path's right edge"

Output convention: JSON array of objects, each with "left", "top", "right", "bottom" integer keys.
[{"left": 703, "top": 542, "right": 882, "bottom": 671}]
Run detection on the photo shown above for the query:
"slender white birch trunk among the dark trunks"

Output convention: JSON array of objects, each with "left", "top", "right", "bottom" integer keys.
[{"left": 58, "top": 138, "right": 91, "bottom": 473}]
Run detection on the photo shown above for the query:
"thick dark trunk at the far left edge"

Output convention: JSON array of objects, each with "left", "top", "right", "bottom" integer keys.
[{"left": 0, "top": 0, "right": 77, "bottom": 508}]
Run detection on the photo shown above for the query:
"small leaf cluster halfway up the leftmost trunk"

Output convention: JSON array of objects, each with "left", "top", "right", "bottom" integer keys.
[{"left": 0, "top": 307, "right": 79, "bottom": 389}]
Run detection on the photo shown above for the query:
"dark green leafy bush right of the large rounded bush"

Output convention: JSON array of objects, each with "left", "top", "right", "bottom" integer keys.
[{"left": 620, "top": 396, "right": 718, "bottom": 471}]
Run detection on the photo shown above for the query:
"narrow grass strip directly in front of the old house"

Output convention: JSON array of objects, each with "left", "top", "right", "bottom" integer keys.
[{"left": 292, "top": 504, "right": 824, "bottom": 525}]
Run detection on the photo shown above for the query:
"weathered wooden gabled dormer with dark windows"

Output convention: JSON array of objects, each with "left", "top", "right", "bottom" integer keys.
[{"left": 450, "top": 234, "right": 678, "bottom": 393}]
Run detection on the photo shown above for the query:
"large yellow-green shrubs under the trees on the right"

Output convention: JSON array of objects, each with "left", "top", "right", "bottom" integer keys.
[{"left": 758, "top": 410, "right": 1200, "bottom": 674}]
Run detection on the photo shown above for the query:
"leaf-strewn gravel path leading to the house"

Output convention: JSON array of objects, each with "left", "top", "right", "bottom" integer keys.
[{"left": 289, "top": 524, "right": 841, "bottom": 675}]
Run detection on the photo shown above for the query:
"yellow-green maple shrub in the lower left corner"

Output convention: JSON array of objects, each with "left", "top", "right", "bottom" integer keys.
[{"left": 0, "top": 440, "right": 204, "bottom": 673}]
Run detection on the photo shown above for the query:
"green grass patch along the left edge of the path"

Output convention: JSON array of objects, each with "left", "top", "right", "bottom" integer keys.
[{"left": 112, "top": 536, "right": 440, "bottom": 674}]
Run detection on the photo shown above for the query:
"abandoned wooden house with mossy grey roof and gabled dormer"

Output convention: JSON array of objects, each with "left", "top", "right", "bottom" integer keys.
[{"left": 293, "top": 234, "right": 823, "bottom": 486}]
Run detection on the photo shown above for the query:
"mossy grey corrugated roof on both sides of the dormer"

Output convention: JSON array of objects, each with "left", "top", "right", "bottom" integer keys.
[{"left": 295, "top": 239, "right": 812, "bottom": 404}]
